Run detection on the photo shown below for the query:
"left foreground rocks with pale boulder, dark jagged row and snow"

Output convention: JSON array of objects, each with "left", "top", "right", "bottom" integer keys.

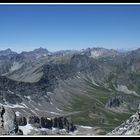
[{"left": 0, "top": 106, "right": 76, "bottom": 135}]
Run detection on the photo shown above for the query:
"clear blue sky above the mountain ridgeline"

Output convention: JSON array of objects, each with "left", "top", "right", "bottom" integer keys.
[{"left": 0, "top": 5, "right": 140, "bottom": 52}]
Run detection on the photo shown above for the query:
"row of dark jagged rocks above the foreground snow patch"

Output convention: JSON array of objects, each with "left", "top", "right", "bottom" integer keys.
[{"left": 17, "top": 116, "right": 76, "bottom": 132}]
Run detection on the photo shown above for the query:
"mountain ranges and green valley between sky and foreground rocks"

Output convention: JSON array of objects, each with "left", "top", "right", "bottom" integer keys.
[{"left": 0, "top": 48, "right": 140, "bottom": 134}]
